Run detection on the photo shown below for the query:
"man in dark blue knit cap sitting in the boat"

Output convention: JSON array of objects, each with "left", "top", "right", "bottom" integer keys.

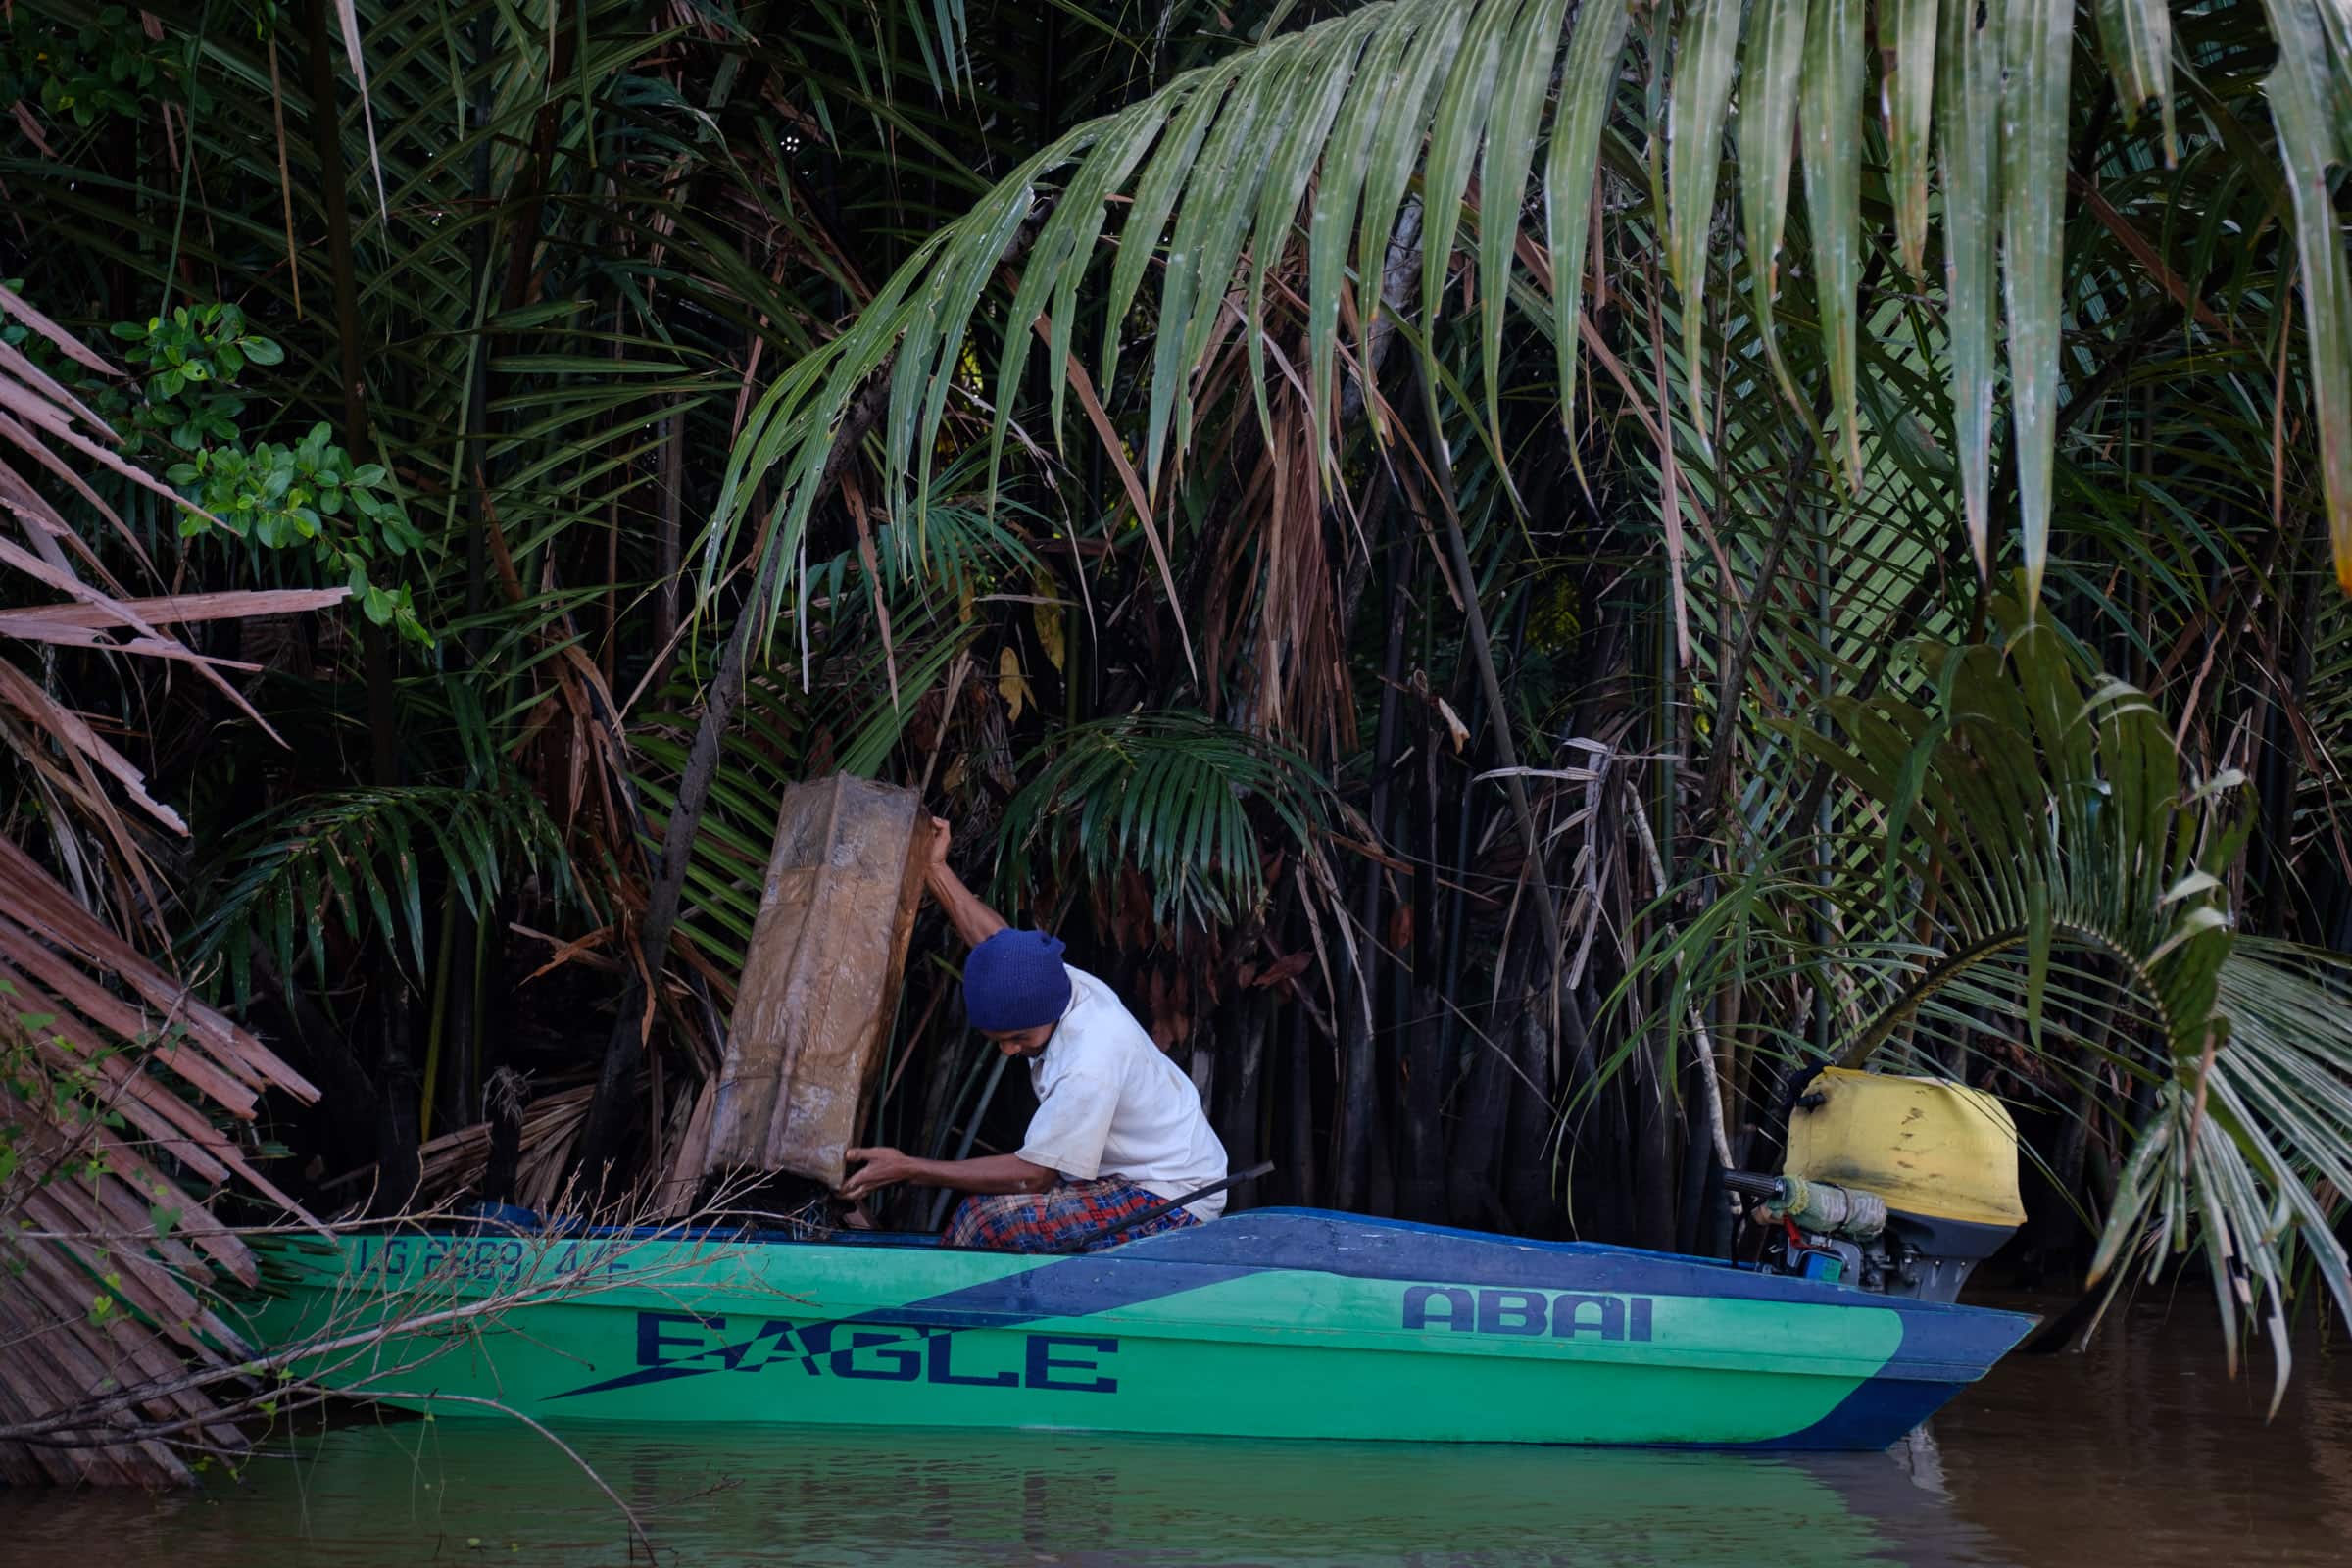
[{"left": 842, "top": 818, "right": 1225, "bottom": 1253}]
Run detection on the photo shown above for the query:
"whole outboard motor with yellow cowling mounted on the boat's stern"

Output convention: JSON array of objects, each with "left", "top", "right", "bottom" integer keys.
[{"left": 1724, "top": 1067, "right": 2025, "bottom": 1302}]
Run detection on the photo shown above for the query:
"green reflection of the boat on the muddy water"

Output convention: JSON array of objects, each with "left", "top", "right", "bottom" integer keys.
[{"left": 4, "top": 1422, "right": 2001, "bottom": 1568}]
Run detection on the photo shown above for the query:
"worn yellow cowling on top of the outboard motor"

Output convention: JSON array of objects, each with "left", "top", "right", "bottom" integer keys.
[{"left": 1788, "top": 1067, "right": 2025, "bottom": 1250}]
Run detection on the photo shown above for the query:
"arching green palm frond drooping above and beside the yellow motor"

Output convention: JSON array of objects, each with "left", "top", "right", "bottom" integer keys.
[{"left": 1674, "top": 602, "right": 2352, "bottom": 1390}]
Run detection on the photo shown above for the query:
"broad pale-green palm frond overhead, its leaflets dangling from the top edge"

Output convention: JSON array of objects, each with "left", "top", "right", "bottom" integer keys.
[{"left": 722, "top": 0, "right": 2352, "bottom": 629}]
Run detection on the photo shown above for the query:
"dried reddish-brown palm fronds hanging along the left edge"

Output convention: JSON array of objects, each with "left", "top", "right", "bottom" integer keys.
[{"left": 0, "top": 287, "right": 331, "bottom": 1484}]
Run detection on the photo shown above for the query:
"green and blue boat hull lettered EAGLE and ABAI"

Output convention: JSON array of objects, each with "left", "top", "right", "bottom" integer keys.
[{"left": 252, "top": 1210, "right": 2033, "bottom": 1448}]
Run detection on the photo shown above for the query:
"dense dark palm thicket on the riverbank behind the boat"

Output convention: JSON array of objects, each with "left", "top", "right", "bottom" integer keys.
[{"left": 0, "top": 0, "right": 2352, "bottom": 1486}]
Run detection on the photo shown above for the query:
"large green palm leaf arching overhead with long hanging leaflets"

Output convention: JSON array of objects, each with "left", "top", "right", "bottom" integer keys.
[{"left": 706, "top": 0, "right": 2352, "bottom": 644}]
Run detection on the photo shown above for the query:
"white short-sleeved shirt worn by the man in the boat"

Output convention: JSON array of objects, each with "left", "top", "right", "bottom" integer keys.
[{"left": 1018, "top": 964, "right": 1225, "bottom": 1220}]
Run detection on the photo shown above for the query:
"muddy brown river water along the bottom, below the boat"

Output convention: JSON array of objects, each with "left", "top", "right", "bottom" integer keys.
[{"left": 0, "top": 1300, "right": 2352, "bottom": 1568}]
